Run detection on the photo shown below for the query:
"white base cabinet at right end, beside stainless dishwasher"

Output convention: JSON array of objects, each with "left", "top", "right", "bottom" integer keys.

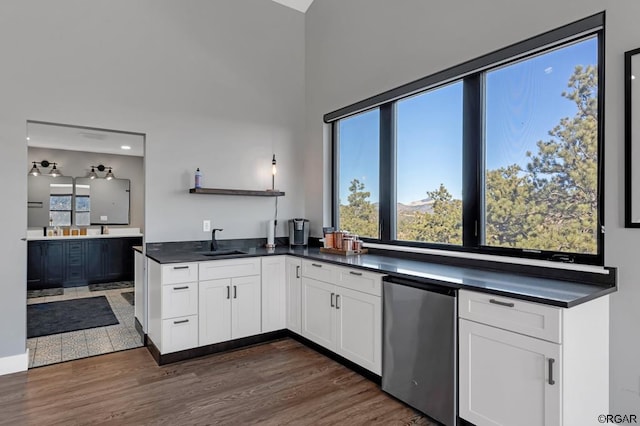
[{"left": 458, "top": 290, "right": 609, "bottom": 426}]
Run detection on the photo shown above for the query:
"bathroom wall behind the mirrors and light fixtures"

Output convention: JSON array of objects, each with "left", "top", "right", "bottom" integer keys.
[{"left": 27, "top": 148, "right": 144, "bottom": 232}]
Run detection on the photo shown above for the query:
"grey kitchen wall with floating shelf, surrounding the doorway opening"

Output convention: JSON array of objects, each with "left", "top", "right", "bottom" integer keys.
[{"left": 0, "top": 0, "right": 305, "bottom": 361}]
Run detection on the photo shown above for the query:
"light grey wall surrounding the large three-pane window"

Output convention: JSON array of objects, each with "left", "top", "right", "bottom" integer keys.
[{"left": 304, "top": 0, "right": 640, "bottom": 414}]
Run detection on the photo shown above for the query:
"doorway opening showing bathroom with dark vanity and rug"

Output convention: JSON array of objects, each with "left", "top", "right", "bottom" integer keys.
[{"left": 26, "top": 121, "right": 145, "bottom": 368}]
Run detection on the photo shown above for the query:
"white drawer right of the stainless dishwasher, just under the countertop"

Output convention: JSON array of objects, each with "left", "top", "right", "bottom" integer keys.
[{"left": 458, "top": 290, "right": 562, "bottom": 343}]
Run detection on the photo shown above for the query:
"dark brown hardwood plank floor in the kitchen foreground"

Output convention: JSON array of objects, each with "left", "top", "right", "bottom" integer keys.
[{"left": 0, "top": 339, "right": 433, "bottom": 426}]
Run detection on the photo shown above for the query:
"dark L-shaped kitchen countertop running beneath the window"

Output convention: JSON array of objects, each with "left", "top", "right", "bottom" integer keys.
[{"left": 146, "top": 240, "right": 617, "bottom": 308}]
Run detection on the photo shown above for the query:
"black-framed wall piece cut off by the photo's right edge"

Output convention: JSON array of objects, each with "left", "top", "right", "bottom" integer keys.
[{"left": 624, "top": 49, "right": 640, "bottom": 228}]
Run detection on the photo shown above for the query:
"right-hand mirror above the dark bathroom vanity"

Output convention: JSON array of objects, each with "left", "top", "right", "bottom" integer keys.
[{"left": 74, "top": 178, "right": 130, "bottom": 226}]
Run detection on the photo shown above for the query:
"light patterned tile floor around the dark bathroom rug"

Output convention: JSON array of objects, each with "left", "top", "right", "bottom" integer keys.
[{"left": 27, "top": 287, "right": 142, "bottom": 368}]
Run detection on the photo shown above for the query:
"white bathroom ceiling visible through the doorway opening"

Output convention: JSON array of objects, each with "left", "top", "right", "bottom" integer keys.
[{"left": 27, "top": 122, "right": 144, "bottom": 157}]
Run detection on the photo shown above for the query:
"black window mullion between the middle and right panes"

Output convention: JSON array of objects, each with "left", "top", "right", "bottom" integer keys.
[{"left": 462, "top": 74, "right": 483, "bottom": 247}]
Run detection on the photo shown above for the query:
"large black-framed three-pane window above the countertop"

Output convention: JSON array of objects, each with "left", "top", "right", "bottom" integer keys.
[{"left": 325, "top": 13, "right": 604, "bottom": 264}]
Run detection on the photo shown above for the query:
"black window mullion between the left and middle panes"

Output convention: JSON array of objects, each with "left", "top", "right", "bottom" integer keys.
[{"left": 378, "top": 103, "right": 395, "bottom": 241}]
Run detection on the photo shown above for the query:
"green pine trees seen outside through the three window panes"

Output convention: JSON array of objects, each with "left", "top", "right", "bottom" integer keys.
[{"left": 340, "top": 66, "right": 598, "bottom": 253}]
